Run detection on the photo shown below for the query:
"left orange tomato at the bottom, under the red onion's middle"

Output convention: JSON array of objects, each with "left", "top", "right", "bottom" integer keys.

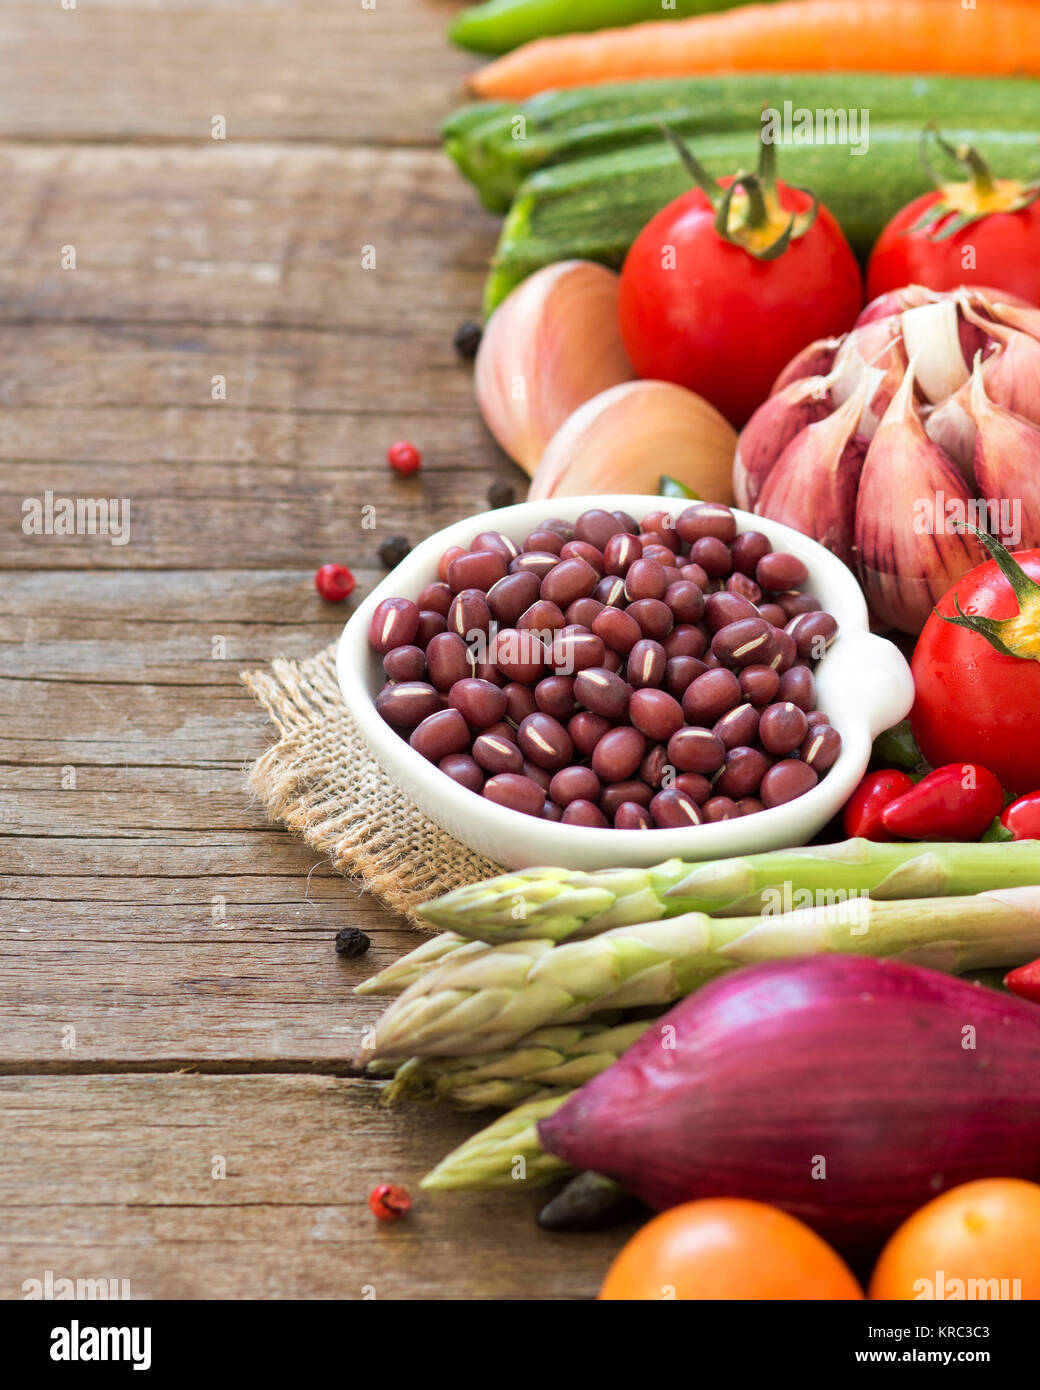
[{"left": 599, "top": 1197, "right": 863, "bottom": 1300}]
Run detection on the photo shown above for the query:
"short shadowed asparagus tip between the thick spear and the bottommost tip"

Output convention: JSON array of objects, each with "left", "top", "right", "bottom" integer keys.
[{"left": 375, "top": 1019, "right": 652, "bottom": 1109}]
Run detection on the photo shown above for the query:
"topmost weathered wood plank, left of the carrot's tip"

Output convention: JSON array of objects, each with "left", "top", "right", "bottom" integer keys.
[{"left": 0, "top": 0, "right": 474, "bottom": 145}]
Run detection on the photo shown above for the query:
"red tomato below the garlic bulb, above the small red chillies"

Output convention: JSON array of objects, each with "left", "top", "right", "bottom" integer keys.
[{"left": 911, "top": 550, "right": 1040, "bottom": 792}]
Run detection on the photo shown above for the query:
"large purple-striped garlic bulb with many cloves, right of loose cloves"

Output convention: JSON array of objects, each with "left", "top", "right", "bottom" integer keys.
[{"left": 734, "top": 285, "right": 1040, "bottom": 632}]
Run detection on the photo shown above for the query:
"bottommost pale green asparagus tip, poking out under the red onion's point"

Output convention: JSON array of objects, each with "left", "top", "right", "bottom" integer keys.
[{"left": 420, "top": 1091, "right": 574, "bottom": 1188}]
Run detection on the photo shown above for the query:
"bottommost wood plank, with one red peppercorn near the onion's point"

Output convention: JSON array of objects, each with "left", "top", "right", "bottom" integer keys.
[{"left": 0, "top": 1076, "right": 627, "bottom": 1298}]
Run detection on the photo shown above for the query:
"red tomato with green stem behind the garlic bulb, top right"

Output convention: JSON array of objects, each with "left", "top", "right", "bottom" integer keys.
[{"left": 866, "top": 132, "right": 1040, "bottom": 303}]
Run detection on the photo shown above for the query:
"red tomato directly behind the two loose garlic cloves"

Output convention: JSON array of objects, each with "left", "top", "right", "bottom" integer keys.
[{"left": 620, "top": 179, "right": 863, "bottom": 427}]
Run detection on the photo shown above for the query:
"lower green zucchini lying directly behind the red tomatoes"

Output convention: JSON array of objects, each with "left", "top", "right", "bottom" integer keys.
[{"left": 484, "top": 120, "right": 1040, "bottom": 314}]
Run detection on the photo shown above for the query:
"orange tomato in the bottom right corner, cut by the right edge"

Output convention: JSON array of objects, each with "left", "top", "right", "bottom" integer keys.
[{"left": 870, "top": 1177, "right": 1040, "bottom": 1298}]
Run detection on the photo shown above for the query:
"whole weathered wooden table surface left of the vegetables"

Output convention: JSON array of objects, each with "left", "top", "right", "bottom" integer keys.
[{"left": 0, "top": 0, "right": 619, "bottom": 1298}]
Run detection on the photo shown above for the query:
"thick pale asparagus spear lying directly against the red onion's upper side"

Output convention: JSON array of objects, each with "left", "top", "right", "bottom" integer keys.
[{"left": 370, "top": 884, "right": 1040, "bottom": 1058}]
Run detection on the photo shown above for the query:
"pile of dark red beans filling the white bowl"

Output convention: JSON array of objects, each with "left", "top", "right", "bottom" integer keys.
[{"left": 368, "top": 502, "right": 841, "bottom": 830}]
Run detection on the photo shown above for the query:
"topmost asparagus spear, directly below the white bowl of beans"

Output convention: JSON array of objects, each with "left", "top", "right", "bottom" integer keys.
[{"left": 420, "top": 840, "right": 1040, "bottom": 941}]
